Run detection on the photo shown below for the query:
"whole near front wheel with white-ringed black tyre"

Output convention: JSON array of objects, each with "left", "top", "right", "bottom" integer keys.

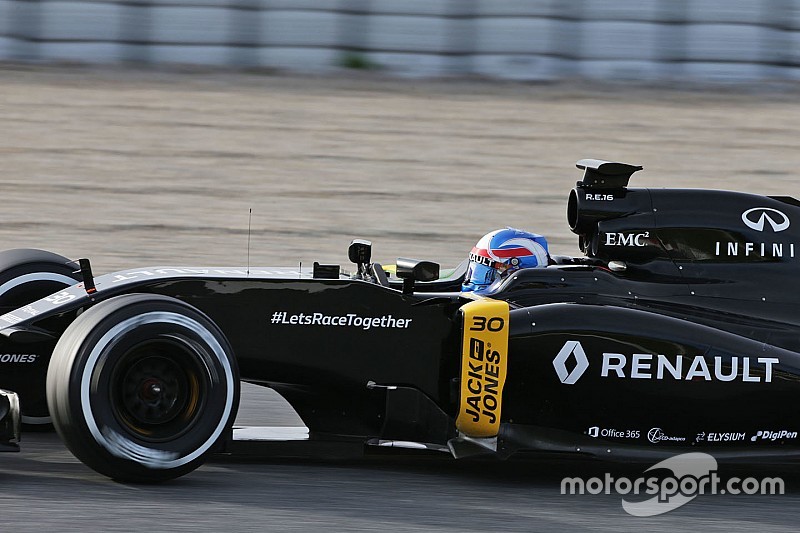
[{"left": 47, "top": 294, "right": 239, "bottom": 483}]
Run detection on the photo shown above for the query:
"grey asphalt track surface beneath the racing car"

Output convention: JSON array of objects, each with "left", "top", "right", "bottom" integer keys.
[{"left": 0, "top": 387, "right": 800, "bottom": 532}]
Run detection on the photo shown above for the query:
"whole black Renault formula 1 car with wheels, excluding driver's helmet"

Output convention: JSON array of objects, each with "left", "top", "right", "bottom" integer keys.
[{"left": 0, "top": 160, "right": 800, "bottom": 481}]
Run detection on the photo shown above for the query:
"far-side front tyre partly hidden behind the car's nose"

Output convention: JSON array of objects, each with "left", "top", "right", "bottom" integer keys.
[{"left": 0, "top": 249, "right": 79, "bottom": 431}]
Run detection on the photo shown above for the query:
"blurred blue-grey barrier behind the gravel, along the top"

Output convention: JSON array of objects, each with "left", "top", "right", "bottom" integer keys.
[{"left": 0, "top": 0, "right": 800, "bottom": 81}]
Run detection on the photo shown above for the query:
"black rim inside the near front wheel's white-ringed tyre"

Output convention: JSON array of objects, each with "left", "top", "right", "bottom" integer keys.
[{"left": 109, "top": 339, "right": 208, "bottom": 442}]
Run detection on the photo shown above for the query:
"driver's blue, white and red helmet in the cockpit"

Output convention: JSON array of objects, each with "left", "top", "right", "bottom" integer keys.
[{"left": 461, "top": 224, "right": 550, "bottom": 292}]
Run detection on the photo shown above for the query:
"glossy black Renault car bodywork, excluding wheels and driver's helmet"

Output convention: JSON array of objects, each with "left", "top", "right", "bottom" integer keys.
[{"left": 0, "top": 160, "right": 800, "bottom": 468}]
